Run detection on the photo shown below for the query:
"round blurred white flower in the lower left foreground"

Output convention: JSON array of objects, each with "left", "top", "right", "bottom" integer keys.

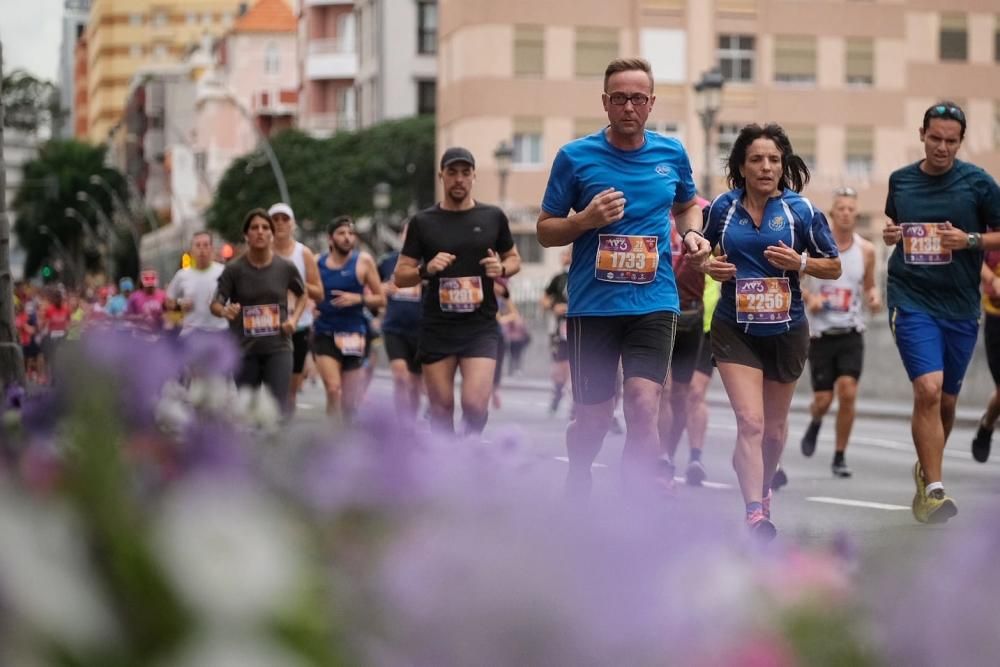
[{"left": 156, "top": 480, "right": 302, "bottom": 625}]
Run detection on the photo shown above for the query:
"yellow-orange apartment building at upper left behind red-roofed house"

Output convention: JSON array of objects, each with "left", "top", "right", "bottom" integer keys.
[{"left": 85, "top": 0, "right": 247, "bottom": 142}]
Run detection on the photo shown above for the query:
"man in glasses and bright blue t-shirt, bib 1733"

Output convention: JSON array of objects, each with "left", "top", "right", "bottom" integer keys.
[{"left": 538, "top": 58, "right": 711, "bottom": 496}]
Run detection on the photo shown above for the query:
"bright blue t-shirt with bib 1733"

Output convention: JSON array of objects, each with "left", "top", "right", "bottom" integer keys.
[{"left": 542, "top": 130, "right": 697, "bottom": 317}]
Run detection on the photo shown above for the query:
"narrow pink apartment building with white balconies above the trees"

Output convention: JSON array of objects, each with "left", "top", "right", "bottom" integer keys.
[{"left": 297, "top": 0, "right": 358, "bottom": 136}]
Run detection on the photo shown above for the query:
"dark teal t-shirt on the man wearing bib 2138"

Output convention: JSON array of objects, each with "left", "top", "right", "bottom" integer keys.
[{"left": 885, "top": 160, "right": 1000, "bottom": 320}]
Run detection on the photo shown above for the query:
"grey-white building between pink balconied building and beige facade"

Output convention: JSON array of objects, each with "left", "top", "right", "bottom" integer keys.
[{"left": 354, "top": 0, "right": 438, "bottom": 127}]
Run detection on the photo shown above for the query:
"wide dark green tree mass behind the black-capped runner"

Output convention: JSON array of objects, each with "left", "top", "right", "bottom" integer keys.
[{"left": 207, "top": 116, "right": 436, "bottom": 241}]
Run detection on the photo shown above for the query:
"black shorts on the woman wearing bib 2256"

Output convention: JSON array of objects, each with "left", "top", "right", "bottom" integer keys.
[{"left": 712, "top": 317, "right": 809, "bottom": 383}]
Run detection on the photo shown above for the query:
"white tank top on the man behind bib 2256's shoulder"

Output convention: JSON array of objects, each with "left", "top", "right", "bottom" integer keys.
[{"left": 808, "top": 234, "right": 865, "bottom": 336}]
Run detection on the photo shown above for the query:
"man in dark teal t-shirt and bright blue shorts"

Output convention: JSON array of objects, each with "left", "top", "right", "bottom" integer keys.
[{"left": 882, "top": 101, "right": 1000, "bottom": 523}]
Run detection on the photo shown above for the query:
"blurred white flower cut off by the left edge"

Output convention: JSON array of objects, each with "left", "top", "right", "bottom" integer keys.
[{"left": 0, "top": 488, "right": 115, "bottom": 645}]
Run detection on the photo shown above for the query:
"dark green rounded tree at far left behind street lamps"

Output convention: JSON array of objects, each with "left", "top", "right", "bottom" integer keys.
[{"left": 13, "top": 139, "right": 131, "bottom": 284}]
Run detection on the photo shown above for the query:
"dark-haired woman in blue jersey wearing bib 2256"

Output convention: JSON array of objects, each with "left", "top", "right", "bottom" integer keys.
[{"left": 705, "top": 124, "right": 840, "bottom": 539}]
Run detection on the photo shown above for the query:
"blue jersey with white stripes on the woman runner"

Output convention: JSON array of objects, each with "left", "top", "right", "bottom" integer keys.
[{"left": 705, "top": 188, "right": 840, "bottom": 336}]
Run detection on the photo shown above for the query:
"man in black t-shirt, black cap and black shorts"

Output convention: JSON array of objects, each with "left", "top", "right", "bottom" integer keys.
[{"left": 393, "top": 148, "right": 521, "bottom": 433}]
